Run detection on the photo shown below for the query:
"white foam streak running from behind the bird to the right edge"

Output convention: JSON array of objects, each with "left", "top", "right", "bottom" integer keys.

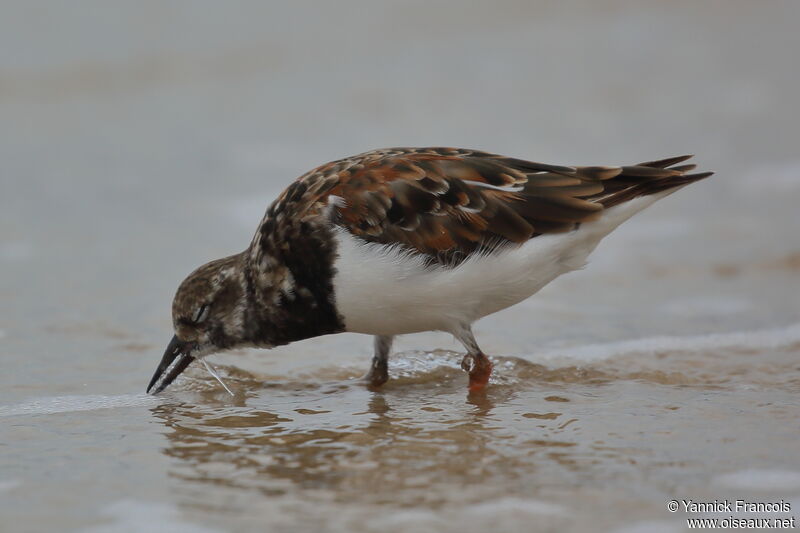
[{"left": 536, "top": 324, "right": 800, "bottom": 362}]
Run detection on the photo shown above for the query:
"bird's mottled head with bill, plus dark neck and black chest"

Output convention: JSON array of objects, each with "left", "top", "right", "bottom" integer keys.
[{"left": 147, "top": 195, "right": 344, "bottom": 393}]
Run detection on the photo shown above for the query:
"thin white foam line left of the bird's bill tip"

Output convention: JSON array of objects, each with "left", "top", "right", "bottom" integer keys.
[{"left": 0, "top": 394, "right": 156, "bottom": 418}]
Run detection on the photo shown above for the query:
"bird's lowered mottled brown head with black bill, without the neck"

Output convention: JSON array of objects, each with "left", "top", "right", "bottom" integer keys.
[{"left": 147, "top": 254, "right": 247, "bottom": 393}]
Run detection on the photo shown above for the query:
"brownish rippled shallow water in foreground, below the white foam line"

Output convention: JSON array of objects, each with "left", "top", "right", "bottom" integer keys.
[{"left": 0, "top": 330, "right": 800, "bottom": 531}]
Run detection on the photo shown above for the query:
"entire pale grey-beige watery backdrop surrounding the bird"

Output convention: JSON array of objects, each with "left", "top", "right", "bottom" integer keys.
[{"left": 0, "top": 0, "right": 800, "bottom": 531}]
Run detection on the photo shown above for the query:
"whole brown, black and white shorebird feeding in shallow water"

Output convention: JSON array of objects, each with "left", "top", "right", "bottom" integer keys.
[{"left": 147, "top": 147, "right": 713, "bottom": 394}]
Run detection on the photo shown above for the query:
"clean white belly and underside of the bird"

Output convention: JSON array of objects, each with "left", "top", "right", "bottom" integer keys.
[{"left": 333, "top": 191, "right": 671, "bottom": 335}]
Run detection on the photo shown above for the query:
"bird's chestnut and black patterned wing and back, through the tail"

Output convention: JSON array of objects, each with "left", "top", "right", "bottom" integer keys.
[{"left": 260, "top": 148, "right": 699, "bottom": 264}]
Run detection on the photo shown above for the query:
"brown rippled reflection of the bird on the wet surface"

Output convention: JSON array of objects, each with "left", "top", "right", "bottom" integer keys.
[{"left": 152, "top": 366, "right": 592, "bottom": 504}]
